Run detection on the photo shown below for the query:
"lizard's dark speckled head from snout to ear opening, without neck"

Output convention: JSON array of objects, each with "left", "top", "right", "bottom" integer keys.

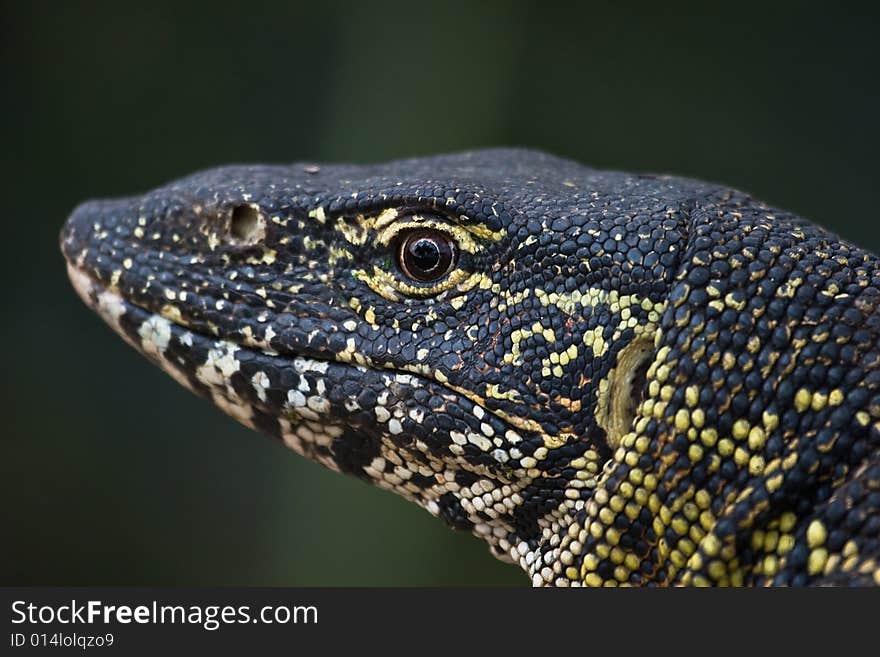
[{"left": 61, "top": 150, "right": 697, "bottom": 571}]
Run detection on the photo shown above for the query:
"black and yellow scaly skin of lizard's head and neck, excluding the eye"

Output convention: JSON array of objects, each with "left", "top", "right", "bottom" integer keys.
[{"left": 61, "top": 150, "right": 880, "bottom": 586}]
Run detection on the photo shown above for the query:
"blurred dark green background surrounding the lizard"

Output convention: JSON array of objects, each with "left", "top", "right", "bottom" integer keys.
[{"left": 0, "top": 2, "right": 880, "bottom": 585}]
